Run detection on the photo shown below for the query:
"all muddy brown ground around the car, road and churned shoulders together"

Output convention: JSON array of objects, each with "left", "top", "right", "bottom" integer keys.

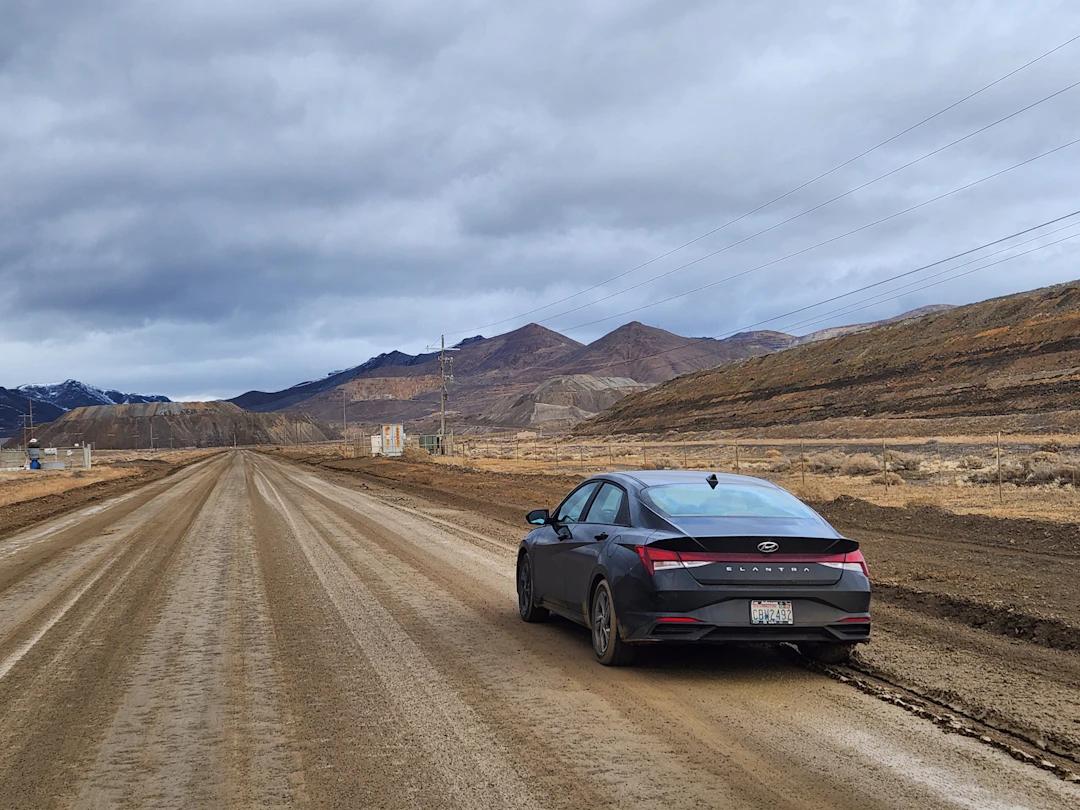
[{"left": 0, "top": 448, "right": 1080, "bottom": 808}]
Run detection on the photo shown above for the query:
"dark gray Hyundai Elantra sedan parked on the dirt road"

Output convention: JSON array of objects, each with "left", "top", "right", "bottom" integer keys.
[{"left": 517, "top": 471, "right": 870, "bottom": 664}]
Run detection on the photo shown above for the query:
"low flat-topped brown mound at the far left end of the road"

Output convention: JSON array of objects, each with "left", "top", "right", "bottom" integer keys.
[{"left": 38, "top": 402, "right": 332, "bottom": 449}]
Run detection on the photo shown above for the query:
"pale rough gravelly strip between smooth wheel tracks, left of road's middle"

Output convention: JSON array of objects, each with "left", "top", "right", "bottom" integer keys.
[{"left": 78, "top": 457, "right": 303, "bottom": 807}]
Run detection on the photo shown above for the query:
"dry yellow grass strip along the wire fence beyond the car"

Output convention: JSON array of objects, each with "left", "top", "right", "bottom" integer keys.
[{"left": 261, "top": 436, "right": 1080, "bottom": 523}]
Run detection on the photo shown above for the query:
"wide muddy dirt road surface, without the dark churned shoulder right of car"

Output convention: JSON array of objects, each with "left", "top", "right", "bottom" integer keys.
[{"left": 0, "top": 450, "right": 1080, "bottom": 808}]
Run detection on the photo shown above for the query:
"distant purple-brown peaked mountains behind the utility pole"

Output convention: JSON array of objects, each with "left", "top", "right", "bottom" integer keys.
[{"left": 229, "top": 306, "right": 949, "bottom": 430}]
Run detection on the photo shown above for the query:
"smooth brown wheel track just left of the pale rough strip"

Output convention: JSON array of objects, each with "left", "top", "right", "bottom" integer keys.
[{"left": 0, "top": 462, "right": 232, "bottom": 807}]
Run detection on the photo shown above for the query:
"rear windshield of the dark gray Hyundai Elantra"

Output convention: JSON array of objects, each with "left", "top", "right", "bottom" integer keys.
[{"left": 642, "top": 482, "right": 815, "bottom": 517}]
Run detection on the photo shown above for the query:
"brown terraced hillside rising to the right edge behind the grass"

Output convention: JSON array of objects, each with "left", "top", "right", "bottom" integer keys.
[{"left": 579, "top": 282, "right": 1080, "bottom": 434}]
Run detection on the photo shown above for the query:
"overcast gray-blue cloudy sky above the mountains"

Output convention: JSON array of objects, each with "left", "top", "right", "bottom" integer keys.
[{"left": 0, "top": 0, "right": 1080, "bottom": 399}]
